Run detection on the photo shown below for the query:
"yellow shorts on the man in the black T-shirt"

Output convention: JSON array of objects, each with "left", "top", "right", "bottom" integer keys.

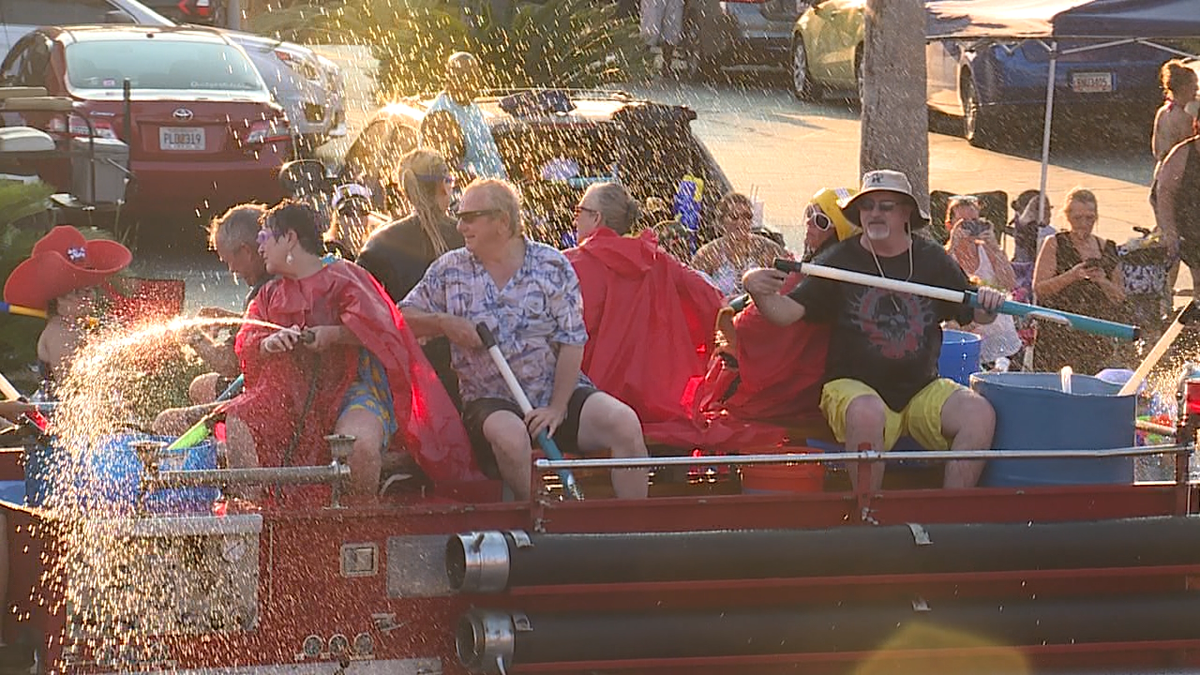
[{"left": 821, "top": 378, "right": 965, "bottom": 450}]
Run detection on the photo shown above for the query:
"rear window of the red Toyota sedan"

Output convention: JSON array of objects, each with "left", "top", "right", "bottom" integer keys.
[{"left": 66, "top": 37, "right": 264, "bottom": 91}]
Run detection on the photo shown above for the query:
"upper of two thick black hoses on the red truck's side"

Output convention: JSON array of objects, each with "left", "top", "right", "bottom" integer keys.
[{"left": 446, "top": 516, "right": 1200, "bottom": 593}]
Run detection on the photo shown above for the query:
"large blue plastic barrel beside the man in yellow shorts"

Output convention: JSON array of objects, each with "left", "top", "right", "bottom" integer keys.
[{"left": 971, "top": 372, "right": 1136, "bottom": 486}]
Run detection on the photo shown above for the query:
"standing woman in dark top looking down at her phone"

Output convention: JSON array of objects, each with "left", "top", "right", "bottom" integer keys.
[{"left": 1033, "top": 187, "right": 1126, "bottom": 375}]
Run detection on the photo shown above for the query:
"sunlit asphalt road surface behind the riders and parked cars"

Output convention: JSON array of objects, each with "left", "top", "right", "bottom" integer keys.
[{"left": 126, "top": 48, "right": 1176, "bottom": 310}]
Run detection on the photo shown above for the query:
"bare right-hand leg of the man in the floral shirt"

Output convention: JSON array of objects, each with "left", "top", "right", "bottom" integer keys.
[{"left": 578, "top": 392, "right": 649, "bottom": 500}]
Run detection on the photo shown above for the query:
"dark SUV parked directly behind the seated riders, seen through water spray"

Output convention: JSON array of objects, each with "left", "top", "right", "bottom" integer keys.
[{"left": 342, "top": 90, "right": 731, "bottom": 245}]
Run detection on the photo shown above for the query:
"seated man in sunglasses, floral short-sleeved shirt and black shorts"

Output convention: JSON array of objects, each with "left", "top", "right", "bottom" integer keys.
[{"left": 400, "top": 179, "right": 647, "bottom": 500}]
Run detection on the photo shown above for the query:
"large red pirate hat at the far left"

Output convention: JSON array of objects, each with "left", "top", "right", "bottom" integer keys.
[{"left": 4, "top": 225, "right": 133, "bottom": 310}]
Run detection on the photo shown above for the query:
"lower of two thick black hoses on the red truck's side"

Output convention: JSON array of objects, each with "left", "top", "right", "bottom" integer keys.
[{"left": 456, "top": 592, "right": 1200, "bottom": 670}]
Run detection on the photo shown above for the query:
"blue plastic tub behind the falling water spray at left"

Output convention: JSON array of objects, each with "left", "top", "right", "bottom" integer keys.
[{"left": 25, "top": 434, "right": 220, "bottom": 514}]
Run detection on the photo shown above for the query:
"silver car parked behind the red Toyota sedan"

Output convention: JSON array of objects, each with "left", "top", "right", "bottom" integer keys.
[{"left": 0, "top": 0, "right": 346, "bottom": 149}]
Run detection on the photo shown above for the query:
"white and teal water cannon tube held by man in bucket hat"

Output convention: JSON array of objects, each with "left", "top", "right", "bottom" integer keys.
[{"left": 774, "top": 258, "right": 1141, "bottom": 341}]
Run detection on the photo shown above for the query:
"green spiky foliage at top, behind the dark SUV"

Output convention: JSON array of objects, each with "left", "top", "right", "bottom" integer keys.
[{"left": 254, "top": 0, "right": 650, "bottom": 95}]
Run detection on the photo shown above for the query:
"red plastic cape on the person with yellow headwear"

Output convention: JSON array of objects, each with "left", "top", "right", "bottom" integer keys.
[{"left": 696, "top": 269, "right": 829, "bottom": 419}]
